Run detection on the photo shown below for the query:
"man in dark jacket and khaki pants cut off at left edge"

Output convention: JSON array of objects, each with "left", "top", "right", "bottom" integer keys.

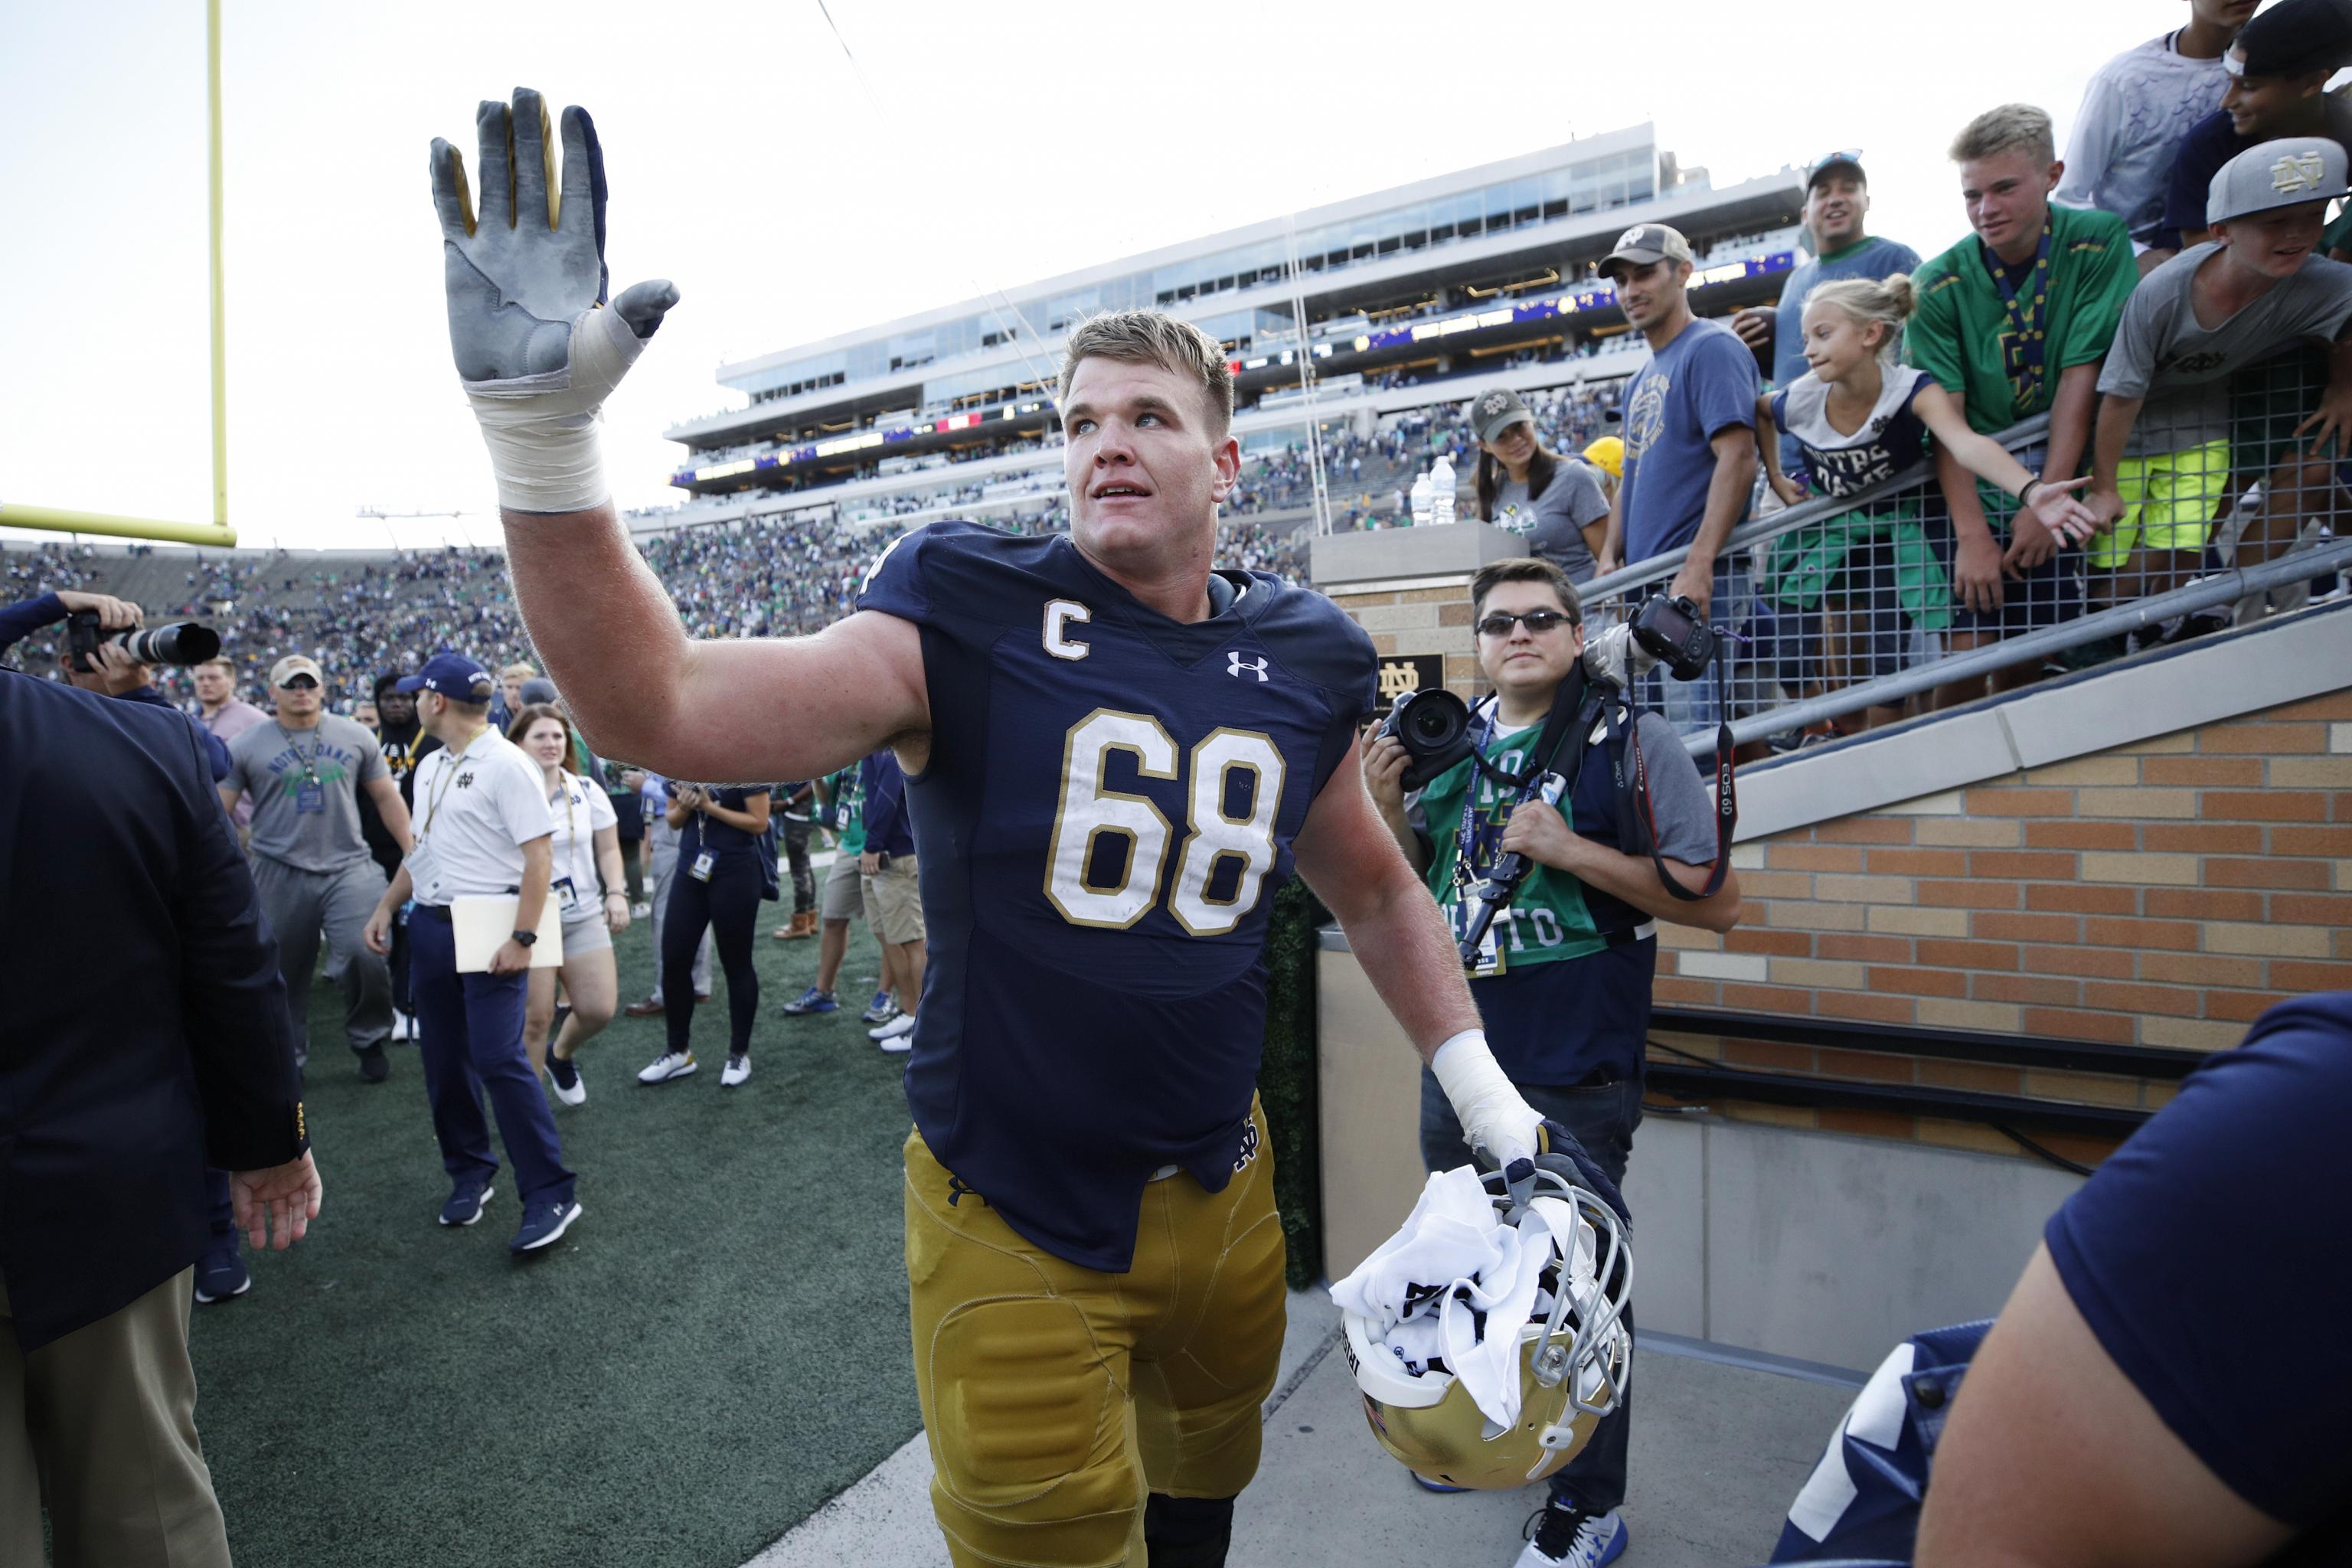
[{"left": 0, "top": 672, "right": 320, "bottom": 1568}]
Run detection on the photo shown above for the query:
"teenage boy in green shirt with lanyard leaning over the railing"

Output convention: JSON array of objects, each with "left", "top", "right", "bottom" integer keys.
[{"left": 1903, "top": 103, "right": 2138, "bottom": 703}]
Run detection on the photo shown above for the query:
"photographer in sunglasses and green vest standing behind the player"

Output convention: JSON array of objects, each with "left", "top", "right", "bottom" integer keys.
[{"left": 1364, "top": 560, "right": 1740, "bottom": 1568}]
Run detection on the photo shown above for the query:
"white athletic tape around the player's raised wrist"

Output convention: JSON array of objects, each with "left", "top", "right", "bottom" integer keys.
[{"left": 463, "top": 305, "right": 645, "bottom": 512}]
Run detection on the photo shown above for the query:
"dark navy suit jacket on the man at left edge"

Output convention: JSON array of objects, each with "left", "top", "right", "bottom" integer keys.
[{"left": 0, "top": 675, "right": 305, "bottom": 1352}]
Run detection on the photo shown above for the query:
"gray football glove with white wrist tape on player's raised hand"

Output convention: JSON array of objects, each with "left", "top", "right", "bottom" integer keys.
[{"left": 433, "top": 87, "right": 678, "bottom": 512}]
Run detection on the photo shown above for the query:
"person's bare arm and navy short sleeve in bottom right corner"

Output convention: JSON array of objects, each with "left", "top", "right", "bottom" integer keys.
[{"left": 1917, "top": 992, "right": 2352, "bottom": 1568}]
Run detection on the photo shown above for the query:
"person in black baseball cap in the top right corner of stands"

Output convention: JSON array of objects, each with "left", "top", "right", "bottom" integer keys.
[{"left": 2164, "top": 0, "right": 2352, "bottom": 252}]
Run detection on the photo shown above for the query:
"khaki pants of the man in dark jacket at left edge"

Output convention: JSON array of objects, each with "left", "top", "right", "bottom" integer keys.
[{"left": 0, "top": 1269, "right": 228, "bottom": 1568}]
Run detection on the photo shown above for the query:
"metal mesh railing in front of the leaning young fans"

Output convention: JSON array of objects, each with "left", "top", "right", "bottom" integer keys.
[{"left": 1583, "top": 348, "right": 2352, "bottom": 755}]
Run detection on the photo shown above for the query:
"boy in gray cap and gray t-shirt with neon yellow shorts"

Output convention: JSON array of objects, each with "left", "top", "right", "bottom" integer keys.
[{"left": 2084, "top": 136, "right": 2352, "bottom": 597}]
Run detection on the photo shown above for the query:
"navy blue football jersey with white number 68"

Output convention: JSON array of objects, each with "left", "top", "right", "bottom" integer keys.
[{"left": 858, "top": 522, "right": 1376, "bottom": 1272}]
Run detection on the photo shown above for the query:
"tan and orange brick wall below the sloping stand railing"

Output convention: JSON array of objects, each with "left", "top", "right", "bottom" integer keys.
[{"left": 1658, "top": 691, "right": 2352, "bottom": 1159}]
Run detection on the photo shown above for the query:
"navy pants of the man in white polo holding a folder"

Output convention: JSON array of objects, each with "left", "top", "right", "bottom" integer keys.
[{"left": 410, "top": 905, "right": 577, "bottom": 1204}]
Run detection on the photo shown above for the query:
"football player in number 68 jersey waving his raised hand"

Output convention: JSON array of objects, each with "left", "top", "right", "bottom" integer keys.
[{"left": 433, "top": 90, "right": 1543, "bottom": 1568}]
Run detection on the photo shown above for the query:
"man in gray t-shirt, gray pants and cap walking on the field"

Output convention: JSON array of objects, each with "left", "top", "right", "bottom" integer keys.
[{"left": 221, "top": 654, "right": 410, "bottom": 1083}]
